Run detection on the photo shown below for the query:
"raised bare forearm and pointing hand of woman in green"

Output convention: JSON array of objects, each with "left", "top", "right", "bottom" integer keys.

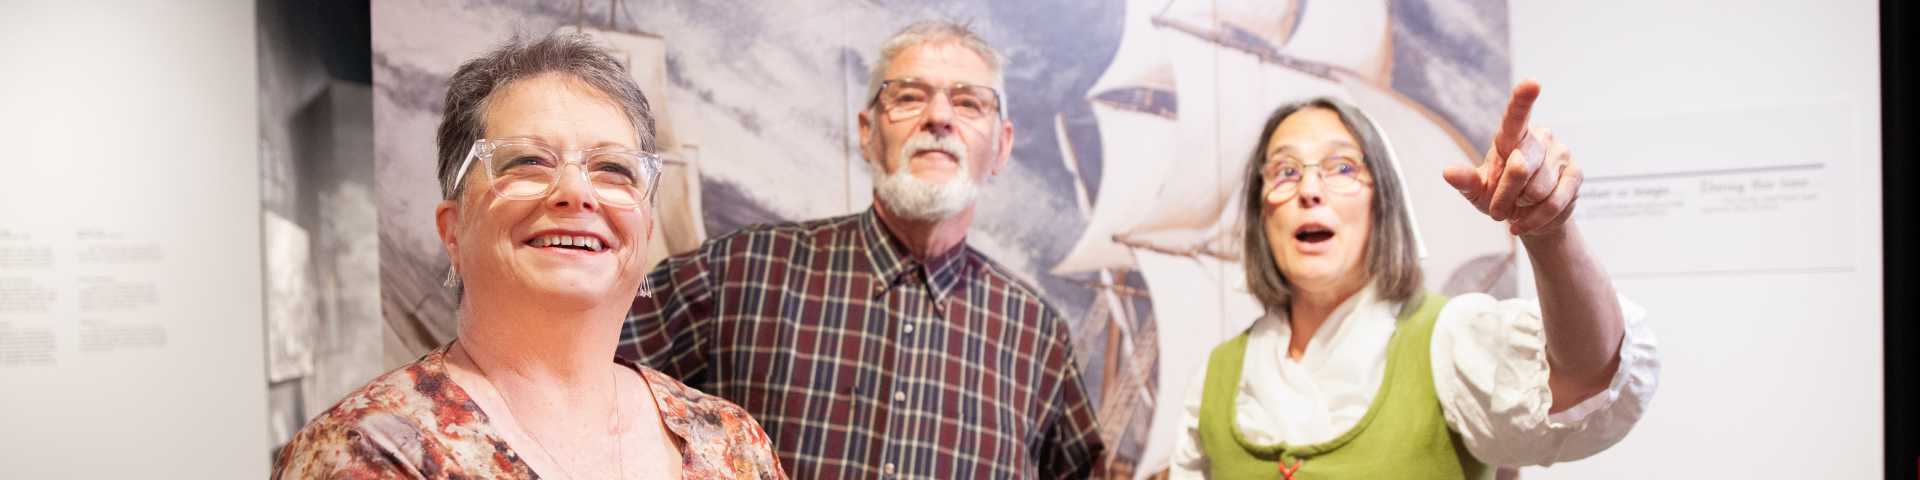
[{"left": 1444, "top": 79, "right": 1624, "bottom": 413}]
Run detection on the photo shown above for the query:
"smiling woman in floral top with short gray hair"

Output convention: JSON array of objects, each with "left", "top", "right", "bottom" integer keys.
[{"left": 275, "top": 33, "right": 785, "bottom": 480}]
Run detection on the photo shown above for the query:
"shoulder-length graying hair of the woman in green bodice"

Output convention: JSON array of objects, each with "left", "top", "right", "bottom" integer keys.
[{"left": 1240, "top": 96, "right": 1421, "bottom": 311}]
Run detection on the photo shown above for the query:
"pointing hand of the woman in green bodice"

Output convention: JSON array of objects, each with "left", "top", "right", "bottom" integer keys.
[{"left": 1442, "top": 79, "right": 1586, "bottom": 236}]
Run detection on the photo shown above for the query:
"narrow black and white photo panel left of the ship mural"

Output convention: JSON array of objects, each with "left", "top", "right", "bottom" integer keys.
[{"left": 255, "top": 0, "right": 388, "bottom": 458}]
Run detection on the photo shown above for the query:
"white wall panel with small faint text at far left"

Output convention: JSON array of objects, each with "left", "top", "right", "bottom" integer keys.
[{"left": 0, "top": 0, "right": 269, "bottom": 478}]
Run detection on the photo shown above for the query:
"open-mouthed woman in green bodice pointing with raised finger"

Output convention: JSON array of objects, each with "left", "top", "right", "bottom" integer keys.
[{"left": 1171, "top": 79, "right": 1659, "bottom": 480}]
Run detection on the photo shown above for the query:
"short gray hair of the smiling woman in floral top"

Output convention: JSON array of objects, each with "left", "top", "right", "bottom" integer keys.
[{"left": 436, "top": 29, "right": 655, "bottom": 200}]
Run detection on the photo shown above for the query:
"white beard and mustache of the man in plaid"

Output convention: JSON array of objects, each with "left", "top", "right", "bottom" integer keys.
[{"left": 872, "top": 132, "right": 979, "bottom": 221}]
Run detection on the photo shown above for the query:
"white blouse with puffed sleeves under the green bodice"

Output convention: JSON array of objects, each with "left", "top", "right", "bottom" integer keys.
[{"left": 1171, "top": 286, "right": 1661, "bottom": 478}]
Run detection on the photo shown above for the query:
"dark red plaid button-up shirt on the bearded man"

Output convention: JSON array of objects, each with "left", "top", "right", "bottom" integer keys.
[{"left": 620, "top": 209, "right": 1102, "bottom": 480}]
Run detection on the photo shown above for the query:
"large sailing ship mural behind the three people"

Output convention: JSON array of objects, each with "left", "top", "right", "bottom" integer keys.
[{"left": 372, "top": 0, "right": 1523, "bottom": 476}]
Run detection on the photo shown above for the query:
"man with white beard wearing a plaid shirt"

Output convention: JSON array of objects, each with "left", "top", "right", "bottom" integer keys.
[{"left": 620, "top": 21, "right": 1104, "bottom": 478}]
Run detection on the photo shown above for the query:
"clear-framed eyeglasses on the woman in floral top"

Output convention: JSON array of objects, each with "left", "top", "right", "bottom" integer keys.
[{"left": 453, "top": 138, "right": 660, "bottom": 209}]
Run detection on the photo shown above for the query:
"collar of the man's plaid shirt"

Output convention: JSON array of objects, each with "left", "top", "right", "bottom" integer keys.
[{"left": 860, "top": 207, "right": 968, "bottom": 303}]
